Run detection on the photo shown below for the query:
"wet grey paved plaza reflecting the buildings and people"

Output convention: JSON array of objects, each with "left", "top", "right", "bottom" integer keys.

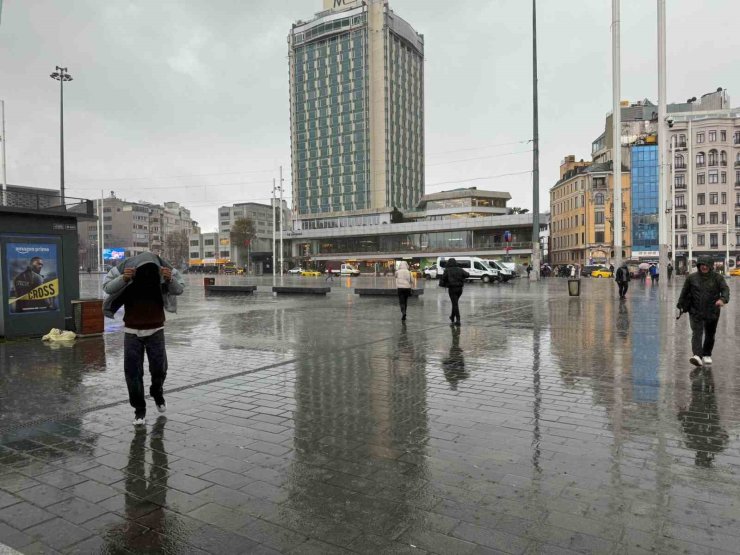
[{"left": 0, "top": 275, "right": 740, "bottom": 554}]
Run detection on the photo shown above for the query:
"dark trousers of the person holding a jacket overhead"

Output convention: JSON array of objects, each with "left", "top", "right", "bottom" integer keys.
[{"left": 123, "top": 330, "right": 167, "bottom": 417}]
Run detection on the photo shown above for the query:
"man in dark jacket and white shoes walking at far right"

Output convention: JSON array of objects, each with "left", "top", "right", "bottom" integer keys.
[{"left": 677, "top": 258, "right": 730, "bottom": 366}]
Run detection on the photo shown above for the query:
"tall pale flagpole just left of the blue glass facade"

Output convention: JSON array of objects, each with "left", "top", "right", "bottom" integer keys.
[{"left": 612, "top": 0, "right": 623, "bottom": 268}]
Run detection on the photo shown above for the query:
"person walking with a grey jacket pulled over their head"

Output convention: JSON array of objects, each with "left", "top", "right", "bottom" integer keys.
[{"left": 103, "top": 252, "right": 184, "bottom": 426}]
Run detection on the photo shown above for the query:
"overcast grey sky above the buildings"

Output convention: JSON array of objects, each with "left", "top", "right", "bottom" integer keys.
[{"left": 0, "top": 0, "right": 740, "bottom": 231}]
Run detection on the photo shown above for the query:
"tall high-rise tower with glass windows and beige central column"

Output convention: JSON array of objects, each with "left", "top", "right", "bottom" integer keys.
[{"left": 288, "top": 0, "right": 424, "bottom": 229}]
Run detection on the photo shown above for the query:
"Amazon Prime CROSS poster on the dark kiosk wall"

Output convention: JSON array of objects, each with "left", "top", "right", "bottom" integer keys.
[{"left": 5, "top": 243, "right": 61, "bottom": 314}]
